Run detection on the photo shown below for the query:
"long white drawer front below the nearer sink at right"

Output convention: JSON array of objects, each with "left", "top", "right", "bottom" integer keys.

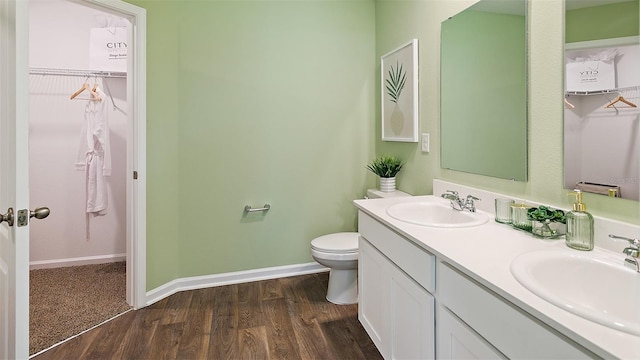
[{"left": 437, "top": 262, "right": 596, "bottom": 359}]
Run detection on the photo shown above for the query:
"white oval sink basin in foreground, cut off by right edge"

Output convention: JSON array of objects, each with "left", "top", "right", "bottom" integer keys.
[{"left": 511, "top": 250, "right": 640, "bottom": 335}]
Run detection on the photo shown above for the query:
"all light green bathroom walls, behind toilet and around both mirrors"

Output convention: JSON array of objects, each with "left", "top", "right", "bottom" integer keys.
[{"left": 128, "top": 0, "right": 640, "bottom": 290}]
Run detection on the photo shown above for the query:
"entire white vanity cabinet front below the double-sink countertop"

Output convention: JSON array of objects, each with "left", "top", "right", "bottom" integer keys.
[{"left": 358, "top": 211, "right": 598, "bottom": 359}]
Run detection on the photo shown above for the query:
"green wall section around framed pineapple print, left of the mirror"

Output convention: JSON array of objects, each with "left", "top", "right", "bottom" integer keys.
[{"left": 373, "top": 0, "right": 476, "bottom": 195}]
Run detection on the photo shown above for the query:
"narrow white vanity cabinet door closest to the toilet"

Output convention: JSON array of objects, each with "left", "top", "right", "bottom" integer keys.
[{"left": 358, "top": 238, "right": 391, "bottom": 359}]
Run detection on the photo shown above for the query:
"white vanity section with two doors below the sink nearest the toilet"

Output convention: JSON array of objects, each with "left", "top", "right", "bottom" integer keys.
[{"left": 358, "top": 215, "right": 435, "bottom": 359}]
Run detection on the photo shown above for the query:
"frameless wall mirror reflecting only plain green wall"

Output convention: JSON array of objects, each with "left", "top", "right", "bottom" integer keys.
[{"left": 440, "top": 0, "right": 527, "bottom": 181}]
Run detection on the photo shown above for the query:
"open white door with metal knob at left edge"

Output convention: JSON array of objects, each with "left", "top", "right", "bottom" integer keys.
[{"left": 0, "top": 0, "right": 29, "bottom": 359}]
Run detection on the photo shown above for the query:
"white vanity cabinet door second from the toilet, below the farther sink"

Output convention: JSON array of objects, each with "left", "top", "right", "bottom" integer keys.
[{"left": 390, "top": 267, "right": 435, "bottom": 359}]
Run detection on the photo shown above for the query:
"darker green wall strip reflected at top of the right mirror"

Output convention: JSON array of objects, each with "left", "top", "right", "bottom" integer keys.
[{"left": 565, "top": 0, "right": 640, "bottom": 43}]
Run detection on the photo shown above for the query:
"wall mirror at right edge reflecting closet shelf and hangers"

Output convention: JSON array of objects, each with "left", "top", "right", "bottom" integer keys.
[{"left": 564, "top": 0, "right": 640, "bottom": 201}]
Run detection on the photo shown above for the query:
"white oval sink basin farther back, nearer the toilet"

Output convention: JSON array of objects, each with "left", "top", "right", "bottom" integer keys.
[{"left": 387, "top": 201, "right": 489, "bottom": 228}]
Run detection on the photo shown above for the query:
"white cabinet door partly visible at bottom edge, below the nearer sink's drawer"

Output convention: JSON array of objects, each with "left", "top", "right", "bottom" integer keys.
[{"left": 436, "top": 306, "right": 506, "bottom": 360}]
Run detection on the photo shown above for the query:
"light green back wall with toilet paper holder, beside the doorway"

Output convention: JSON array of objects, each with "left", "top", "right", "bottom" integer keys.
[{"left": 131, "top": 0, "right": 376, "bottom": 289}]
